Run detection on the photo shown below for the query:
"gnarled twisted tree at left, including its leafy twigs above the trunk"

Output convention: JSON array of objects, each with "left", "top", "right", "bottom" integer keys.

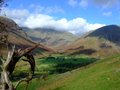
[{"left": 0, "top": 0, "right": 39, "bottom": 90}]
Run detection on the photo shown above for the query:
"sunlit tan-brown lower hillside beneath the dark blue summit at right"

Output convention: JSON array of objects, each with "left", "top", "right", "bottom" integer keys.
[{"left": 61, "top": 37, "right": 120, "bottom": 58}]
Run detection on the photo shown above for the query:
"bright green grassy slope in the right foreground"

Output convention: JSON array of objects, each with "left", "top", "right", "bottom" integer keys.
[{"left": 37, "top": 55, "right": 120, "bottom": 90}]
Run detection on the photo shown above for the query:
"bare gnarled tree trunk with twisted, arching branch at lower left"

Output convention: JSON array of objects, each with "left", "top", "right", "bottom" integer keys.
[{"left": 1, "top": 45, "right": 38, "bottom": 90}]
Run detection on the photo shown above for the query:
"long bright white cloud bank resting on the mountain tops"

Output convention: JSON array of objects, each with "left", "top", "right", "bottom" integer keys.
[{"left": 25, "top": 14, "right": 104, "bottom": 34}]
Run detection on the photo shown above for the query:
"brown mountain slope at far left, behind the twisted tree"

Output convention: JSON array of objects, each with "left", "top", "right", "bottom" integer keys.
[{"left": 0, "top": 16, "right": 51, "bottom": 54}]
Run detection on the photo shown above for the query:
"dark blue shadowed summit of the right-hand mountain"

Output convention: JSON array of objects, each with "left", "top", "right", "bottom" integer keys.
[{"left": 85, "top": 25, "right": 120, "bottom": 45}]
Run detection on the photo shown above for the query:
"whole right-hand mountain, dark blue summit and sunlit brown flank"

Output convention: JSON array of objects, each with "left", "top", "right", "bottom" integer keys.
[{"left": 60, "top": 25, "right": 120, "bottom": 57}]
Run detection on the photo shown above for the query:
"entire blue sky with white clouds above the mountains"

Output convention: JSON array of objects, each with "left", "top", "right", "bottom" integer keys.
[{"left": 1, "top": 0, "right": 120, "bottom": 34}]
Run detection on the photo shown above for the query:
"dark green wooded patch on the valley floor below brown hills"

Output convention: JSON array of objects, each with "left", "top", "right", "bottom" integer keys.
[{"left": 36, "top": 56, "right": 96, "bottom": 74}]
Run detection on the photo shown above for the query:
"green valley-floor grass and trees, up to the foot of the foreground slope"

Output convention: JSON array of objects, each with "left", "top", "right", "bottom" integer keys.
[{"left": 14, "top": 56, "right": 96, "bottom": 90}]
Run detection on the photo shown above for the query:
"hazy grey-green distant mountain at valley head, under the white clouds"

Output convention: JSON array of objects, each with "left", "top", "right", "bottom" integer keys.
[{"left": 22, "top": 27, "right": 78, "bottom": 47}]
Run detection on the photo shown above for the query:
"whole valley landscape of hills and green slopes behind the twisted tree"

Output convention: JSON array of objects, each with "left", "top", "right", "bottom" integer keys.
[{"left": 0, "top": 17, "right": 120, "bottom": 90}]
